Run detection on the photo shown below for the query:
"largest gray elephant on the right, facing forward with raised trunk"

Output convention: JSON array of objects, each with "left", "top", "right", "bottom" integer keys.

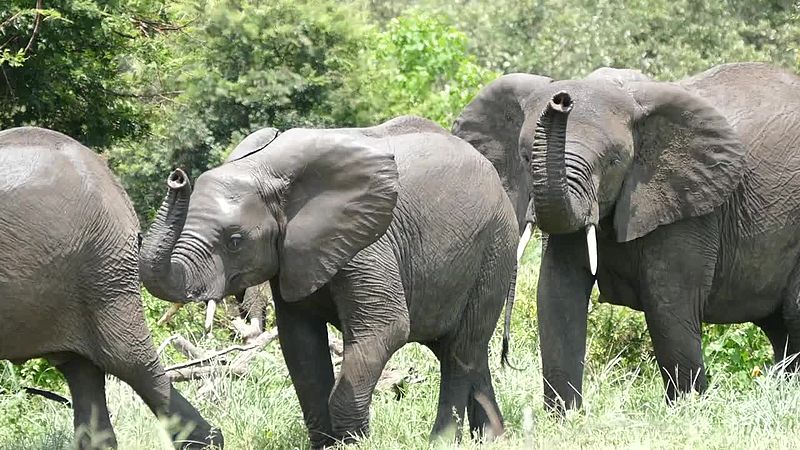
[{"left": 462, "top": 63, "right": 800, "bottom": 409}]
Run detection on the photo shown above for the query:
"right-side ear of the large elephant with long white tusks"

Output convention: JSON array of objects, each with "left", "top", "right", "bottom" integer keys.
[{"left": 614, "top": 82, "right": 746, "bottom": 242}]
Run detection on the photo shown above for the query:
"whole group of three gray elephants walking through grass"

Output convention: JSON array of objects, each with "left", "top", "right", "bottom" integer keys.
[{"left": 0, "top": 63, "right": 800, "bottom": 448}]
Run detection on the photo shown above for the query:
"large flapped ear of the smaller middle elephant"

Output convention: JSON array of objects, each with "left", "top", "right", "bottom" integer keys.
[{"left": 276, "top": 130, "right": 398, "bottom": 301}]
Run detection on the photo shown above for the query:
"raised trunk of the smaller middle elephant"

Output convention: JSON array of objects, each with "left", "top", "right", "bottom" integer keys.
[{"left": 139, "top": 169, "right": 192, "bottom": 303}]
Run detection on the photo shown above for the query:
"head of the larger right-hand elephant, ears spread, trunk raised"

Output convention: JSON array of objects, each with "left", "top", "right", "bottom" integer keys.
[{"left": 454, "top": 68, "right": 744, "bottom": 265}]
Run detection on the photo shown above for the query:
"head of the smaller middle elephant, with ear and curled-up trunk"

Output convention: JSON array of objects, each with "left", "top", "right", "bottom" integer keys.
[{"left": 139, "top": 129, "right": 398, "bottom": 312}]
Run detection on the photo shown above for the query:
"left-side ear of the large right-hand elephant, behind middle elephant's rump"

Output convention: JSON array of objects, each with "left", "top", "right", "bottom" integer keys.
[{"left": 453, "top": 73, "right": 553, "bottom": 232}]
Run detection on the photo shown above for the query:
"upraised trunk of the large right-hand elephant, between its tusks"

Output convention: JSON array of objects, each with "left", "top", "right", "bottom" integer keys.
[{"left": 530, "top": 92, "right": 596, "bottom": 234}]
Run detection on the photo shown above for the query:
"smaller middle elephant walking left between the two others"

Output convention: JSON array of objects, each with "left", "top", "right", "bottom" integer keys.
[{"left": 140, "top": 117, "right": 518, "bottom": 447}]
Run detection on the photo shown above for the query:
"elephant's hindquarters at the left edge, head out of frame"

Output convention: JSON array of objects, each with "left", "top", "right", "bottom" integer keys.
[{"left": 0, "top": 127, "right": 222, "bottom": 449}]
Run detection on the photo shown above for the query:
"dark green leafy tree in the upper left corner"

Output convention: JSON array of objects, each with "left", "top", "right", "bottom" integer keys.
[{"left": 0, "top": 0, "right": 166, "bottom": 147}]
